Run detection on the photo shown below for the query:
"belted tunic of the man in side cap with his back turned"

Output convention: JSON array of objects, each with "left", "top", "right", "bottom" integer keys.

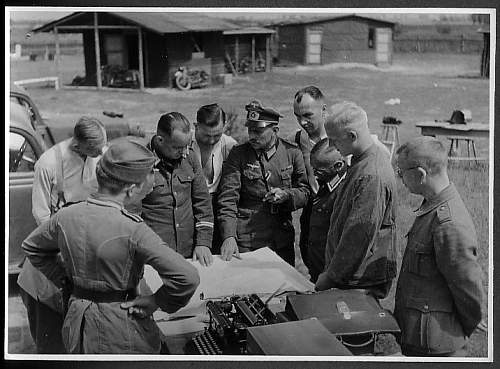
[{"left": 23, "top": 194, "right": 199, "bottom": 354}]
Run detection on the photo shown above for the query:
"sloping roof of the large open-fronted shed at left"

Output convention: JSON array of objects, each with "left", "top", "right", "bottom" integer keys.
[{"left": 33, "top": 12, "right": 240, "bottom": 34}]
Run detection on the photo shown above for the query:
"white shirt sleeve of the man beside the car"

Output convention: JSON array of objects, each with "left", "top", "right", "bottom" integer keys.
[{"left": 31, "top": 160, "right": 55, "bottom": 224}]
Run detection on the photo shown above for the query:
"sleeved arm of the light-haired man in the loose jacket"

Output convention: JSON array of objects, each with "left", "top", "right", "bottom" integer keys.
[{"left": 316, "top": 176, "right": 386, "bottom": 291}]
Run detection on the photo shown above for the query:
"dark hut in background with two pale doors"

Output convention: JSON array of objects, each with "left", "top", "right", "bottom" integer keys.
[{"left": 273, "top": 14, "right": 395, "bottom": 65}]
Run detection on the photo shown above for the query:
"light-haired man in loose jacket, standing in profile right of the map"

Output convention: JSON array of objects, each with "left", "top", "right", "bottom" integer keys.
[{"left": 316, "top": 102, "right": 396, "bottom": 298}]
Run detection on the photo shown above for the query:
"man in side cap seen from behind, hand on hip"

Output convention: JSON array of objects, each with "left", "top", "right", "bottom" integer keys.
[{"left": 22, "top": 138, "right": 199, "bottom": 354}]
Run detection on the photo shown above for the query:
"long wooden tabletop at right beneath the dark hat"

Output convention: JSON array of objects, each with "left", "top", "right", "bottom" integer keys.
[{"left": 416, "top": 122, "right": 490, "bottom": 138}]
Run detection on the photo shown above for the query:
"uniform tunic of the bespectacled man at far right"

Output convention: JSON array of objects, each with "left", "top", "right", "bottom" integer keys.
[{"left": 394, "top": 184, "right": 483, "bottom": 355}]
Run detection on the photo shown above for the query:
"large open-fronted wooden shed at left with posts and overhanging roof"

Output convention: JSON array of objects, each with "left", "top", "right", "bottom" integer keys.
[{"left": 33, "top": 12, "right": 240, "bottom": 89}]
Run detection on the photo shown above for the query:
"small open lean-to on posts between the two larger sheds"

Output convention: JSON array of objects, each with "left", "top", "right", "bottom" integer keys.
[{"left": 223, "top": 27, "right": 276, "bottom": 73}]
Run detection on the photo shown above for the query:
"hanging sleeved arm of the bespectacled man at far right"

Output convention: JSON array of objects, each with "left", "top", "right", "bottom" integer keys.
[{"left": 433, "top": 221, "right": 484, "bottom": 336}]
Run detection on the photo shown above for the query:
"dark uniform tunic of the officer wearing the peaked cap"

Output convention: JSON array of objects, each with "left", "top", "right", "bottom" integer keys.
[{"left": 217, "top": 138, "right": 310, "bottom": 254}]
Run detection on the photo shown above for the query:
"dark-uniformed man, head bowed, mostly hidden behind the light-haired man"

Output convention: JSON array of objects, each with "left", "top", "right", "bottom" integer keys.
[{"left": 306, "top": 138, "right": 347, "bottom": 282}]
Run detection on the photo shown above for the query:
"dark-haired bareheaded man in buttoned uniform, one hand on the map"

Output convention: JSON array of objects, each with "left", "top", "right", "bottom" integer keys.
[{"left": 142, "top": 112, "right": 214, "bottom": 265}]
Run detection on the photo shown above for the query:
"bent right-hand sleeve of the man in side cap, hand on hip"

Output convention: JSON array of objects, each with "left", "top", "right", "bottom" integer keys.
[{"left": 134, "top": 223, "right": 200, "bottom": 313}]
